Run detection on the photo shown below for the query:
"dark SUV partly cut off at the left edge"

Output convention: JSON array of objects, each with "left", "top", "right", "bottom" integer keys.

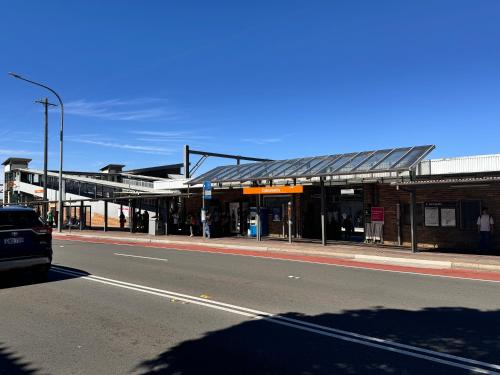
[{"left": 0, "top": 206, "right": 52, "bottom": 280}]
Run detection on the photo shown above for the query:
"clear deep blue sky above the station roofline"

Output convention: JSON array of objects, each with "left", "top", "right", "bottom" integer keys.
[{"left": 0, "top": 0, "right": 500, "bottom": 181}]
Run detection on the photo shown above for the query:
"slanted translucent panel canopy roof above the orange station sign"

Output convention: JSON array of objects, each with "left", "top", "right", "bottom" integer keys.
[{"left": 189, "top": 145, "right": 435, "bottom": 185}]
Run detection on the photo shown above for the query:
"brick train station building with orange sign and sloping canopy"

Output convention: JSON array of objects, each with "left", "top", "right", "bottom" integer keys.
[{"left": 3, "top": 145, "right": 500, "bottom": 251}]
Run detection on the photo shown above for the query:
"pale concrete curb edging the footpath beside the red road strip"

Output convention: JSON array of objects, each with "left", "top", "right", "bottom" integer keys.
[{"left": 54, "top": 233, "right": 500, "bottom": 272}]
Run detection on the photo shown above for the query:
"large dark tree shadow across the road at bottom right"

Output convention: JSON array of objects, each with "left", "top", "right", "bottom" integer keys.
[{"left": 133, "top": 307, "right": 500, "bottom": 375}]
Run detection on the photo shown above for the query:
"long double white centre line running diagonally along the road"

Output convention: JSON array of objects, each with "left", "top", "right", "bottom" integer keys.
[{"left": 52, "top": 266, "right": 500, "bottom": 374}]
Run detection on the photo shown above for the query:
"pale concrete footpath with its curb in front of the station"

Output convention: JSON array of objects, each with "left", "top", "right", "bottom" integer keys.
[{"left": 53, "top": 231, "right": 500, "bottom": 272}]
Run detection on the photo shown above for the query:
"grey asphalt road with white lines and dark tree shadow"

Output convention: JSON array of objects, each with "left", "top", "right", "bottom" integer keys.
[{"left": 0, "top": 241, "right": 500, "bottom": 375}]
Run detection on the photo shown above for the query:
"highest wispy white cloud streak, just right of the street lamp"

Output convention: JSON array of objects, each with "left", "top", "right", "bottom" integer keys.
[{"left": 65, "top": 98, "right": 180, "bottom": 121}]
